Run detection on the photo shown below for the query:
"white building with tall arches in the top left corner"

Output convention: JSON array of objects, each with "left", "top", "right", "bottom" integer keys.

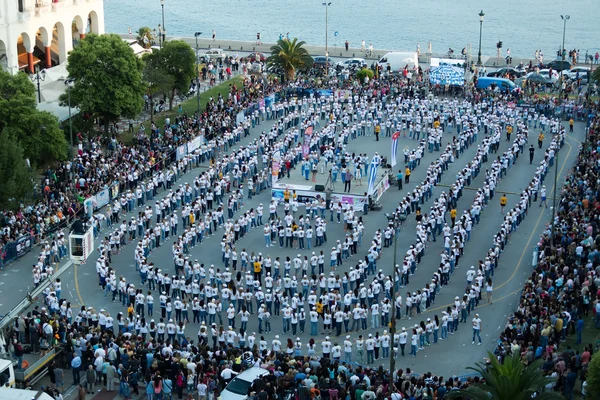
[{"left": 0, "top": 0, "right": 104, "bottom": 74}]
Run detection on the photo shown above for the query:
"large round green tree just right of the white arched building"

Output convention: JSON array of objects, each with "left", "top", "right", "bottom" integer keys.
[{"left": 60, "top": 34, "right": 146, "bottom": 134}]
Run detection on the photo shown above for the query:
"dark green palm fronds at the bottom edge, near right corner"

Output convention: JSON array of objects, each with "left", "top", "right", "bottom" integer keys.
[{"left": 447, "top": 353, "right": 564, "bottom": 400}]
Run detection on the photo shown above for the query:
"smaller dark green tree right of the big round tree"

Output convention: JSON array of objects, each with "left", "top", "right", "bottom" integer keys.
[{"left": 144, "top": 40, "right": 196, "bottom": 109}]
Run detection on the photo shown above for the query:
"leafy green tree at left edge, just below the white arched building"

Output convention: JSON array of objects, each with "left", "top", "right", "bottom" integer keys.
[{"left": 0, "top": 71, "right": 68, "bottom": 164}]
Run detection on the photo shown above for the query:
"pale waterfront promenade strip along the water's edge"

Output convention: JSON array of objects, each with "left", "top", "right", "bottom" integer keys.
[{"left": 117, "top": 32, "right": 544, "bottom": 68}]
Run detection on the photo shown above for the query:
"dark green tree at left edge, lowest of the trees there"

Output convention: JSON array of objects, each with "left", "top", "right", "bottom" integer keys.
[{"left": 0, "top": 133, "right": 33, "bottom": 209}]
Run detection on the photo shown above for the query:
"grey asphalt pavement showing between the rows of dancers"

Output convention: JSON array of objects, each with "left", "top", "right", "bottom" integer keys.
[{"left": 0, "top": 111, "right": 585, "bottom": 376}]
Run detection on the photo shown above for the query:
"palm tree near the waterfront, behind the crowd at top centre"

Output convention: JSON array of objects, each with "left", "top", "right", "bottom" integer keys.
[{"left": 267, "top": 38, "right": 314, "bottom": 80}]
